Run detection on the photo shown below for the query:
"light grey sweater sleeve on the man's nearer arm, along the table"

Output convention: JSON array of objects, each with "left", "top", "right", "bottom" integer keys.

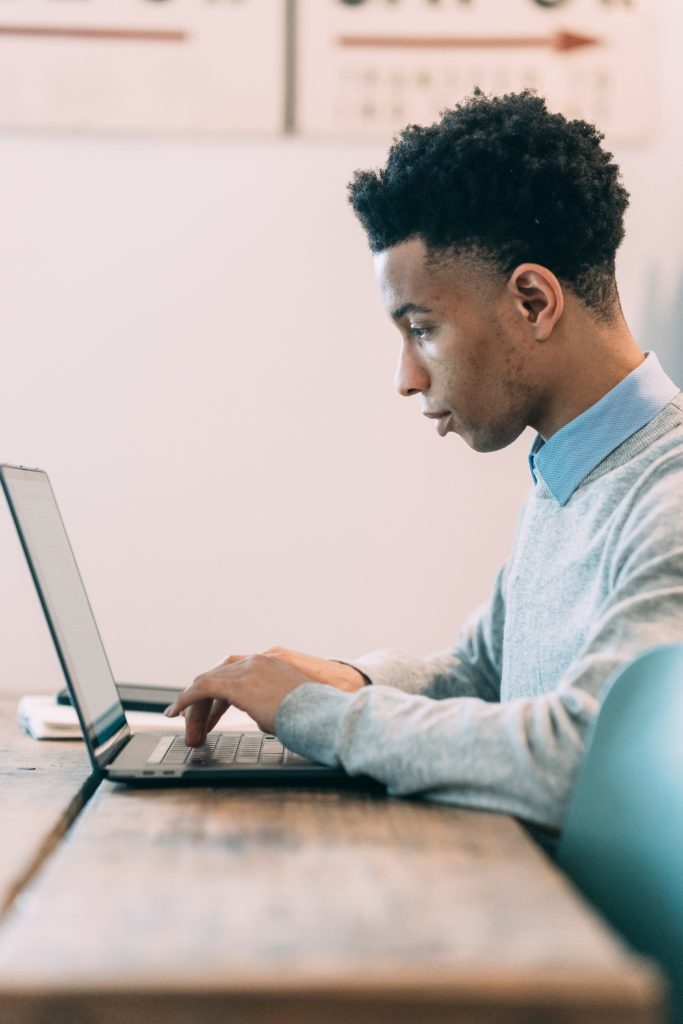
[{"left": 275, "top": 473, "right": 683, "bottom": 828}]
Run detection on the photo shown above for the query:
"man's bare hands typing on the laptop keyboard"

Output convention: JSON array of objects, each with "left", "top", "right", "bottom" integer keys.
[{"left": 165, "top": 647, "right": 364, "bottom": 746}]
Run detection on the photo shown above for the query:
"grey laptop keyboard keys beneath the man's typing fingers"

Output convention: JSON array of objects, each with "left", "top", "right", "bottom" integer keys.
[{"left": 146, "top": 732, "right": 308, "bottom": 768}]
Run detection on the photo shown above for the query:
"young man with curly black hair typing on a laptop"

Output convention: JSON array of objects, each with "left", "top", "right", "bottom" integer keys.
[{"left": 168, "top": 92, "right": 683, "bottom": 828}]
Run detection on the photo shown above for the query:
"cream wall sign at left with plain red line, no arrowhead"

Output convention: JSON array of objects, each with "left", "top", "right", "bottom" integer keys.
[{"left": 0, "top": 0, "right": 286, "bottom": 133}]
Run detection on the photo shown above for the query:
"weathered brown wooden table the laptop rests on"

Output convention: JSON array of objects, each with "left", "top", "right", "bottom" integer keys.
[{"left": 0, "top": 703, "right": 663, "bottom": 1024}]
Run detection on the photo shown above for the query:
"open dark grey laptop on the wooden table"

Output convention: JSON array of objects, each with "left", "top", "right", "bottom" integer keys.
[{"left": 0, "top": 466, "right": 348, "bottom": 785}]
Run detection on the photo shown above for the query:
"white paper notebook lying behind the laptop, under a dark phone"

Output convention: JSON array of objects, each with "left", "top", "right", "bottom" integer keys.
[{"left": 16, "top": 693, "right": 258, "bottom": 739}]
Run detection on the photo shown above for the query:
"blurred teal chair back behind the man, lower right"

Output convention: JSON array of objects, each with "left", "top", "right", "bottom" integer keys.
[{"left": 557, "top": 644, "right": 683, "bottom": 1024}]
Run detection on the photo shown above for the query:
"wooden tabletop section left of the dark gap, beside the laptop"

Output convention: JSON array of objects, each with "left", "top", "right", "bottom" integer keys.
[{"left": 0, "top": 697, "right": 90, "bottom": 916}]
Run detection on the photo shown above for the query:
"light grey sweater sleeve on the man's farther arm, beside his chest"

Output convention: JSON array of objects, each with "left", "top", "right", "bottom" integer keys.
[{"left": 337, "top": 565, "right": 507, "bottom": 700}]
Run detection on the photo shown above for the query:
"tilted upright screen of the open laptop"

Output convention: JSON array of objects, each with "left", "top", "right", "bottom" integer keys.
[{"left": 0, "top": 466, "right": 126, "bottom": 760}]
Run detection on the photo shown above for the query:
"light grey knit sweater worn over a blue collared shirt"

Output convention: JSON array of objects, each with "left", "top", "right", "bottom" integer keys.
[{"left": 276, "top": 394, "right": 683, "bottom": 828}]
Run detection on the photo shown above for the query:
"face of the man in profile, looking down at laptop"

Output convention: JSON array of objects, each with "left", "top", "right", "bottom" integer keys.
[{"left": 375, "top": 238, "right": 540, "bottom": 452}]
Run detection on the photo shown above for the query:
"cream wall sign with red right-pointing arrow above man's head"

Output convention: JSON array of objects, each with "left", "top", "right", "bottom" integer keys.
[{"left": 297, "top": 0, "right": 656, "bottom": 142}]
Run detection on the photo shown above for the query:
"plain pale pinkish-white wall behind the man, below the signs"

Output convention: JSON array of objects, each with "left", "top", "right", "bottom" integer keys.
[{"left": 0, "top": 0, "right": 683, "bottom": 692}]
